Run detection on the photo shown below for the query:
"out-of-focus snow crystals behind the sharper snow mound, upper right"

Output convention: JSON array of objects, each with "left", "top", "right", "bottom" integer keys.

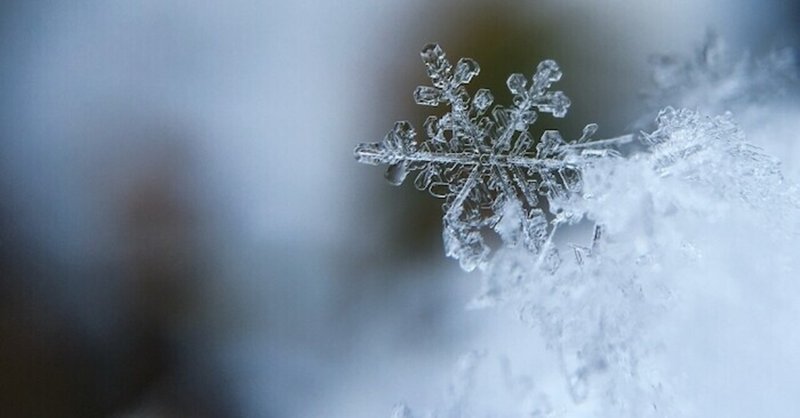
[{"left": 635, "top": 33, "right": 800, "bottom": 188}]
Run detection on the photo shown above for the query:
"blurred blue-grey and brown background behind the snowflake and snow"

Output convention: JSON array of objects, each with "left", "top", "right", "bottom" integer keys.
[{"left": 0, "top": 0, "right": 800, "bottom": 417}]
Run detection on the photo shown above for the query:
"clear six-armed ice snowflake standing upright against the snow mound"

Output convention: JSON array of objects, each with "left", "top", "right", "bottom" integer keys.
[{"left": 354, "top": 44, "right": 633, "bottom": 271}]
